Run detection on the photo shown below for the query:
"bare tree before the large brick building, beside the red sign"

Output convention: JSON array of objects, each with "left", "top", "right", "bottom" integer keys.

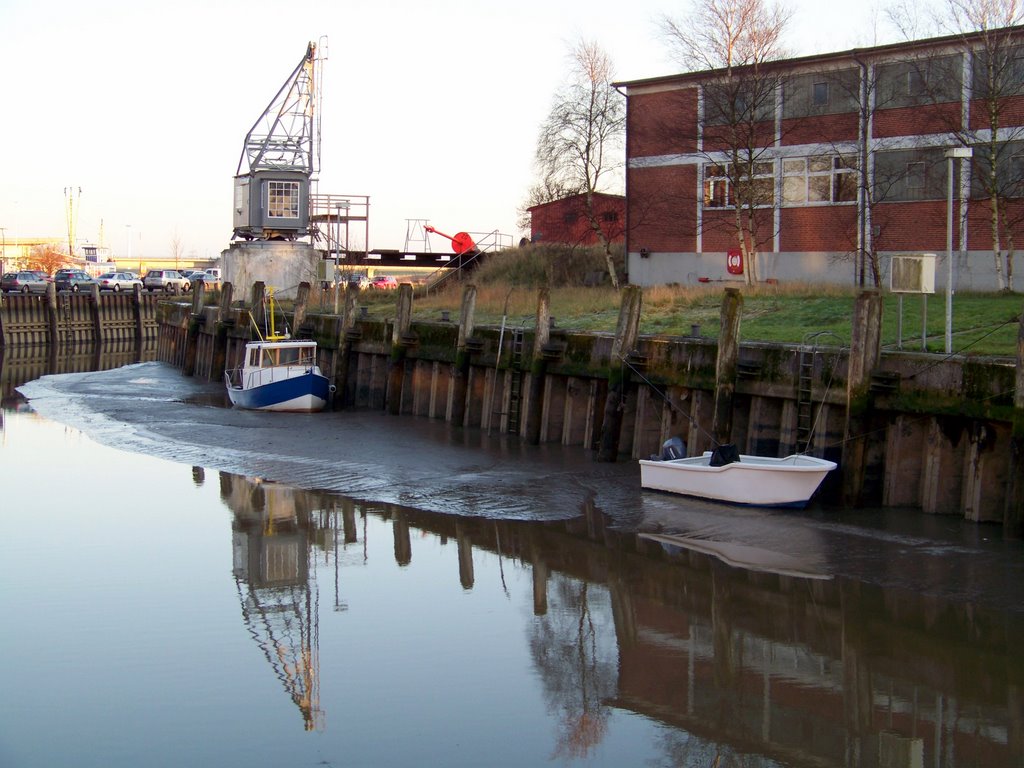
[{"left": 659, "top": 0, "right": 791, "bottom": 285}]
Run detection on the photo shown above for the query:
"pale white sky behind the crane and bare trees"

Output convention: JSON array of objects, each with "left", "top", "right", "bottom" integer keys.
[{"left": 0, "top": 0, "right": 929, "bottom": 259}]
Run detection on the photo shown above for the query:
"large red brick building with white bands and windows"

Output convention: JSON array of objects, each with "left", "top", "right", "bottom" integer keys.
[{"left": 616, "top": 27, "right": 1024, "bottom": 290}]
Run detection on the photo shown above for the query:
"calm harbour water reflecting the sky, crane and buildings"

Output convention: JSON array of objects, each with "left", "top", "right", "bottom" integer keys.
[{"left": 0, "top": 352, "right": 1024, "bottom": 768}]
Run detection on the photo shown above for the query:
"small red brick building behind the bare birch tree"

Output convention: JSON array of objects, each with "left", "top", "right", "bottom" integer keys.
[{"left": 527, "top": 193, "right": 626, "bottom": 246}]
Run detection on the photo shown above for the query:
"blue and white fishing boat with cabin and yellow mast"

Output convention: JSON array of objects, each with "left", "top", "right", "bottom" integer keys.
[{"left": 224, "top": 292, "right": 332, "bottom": 413}]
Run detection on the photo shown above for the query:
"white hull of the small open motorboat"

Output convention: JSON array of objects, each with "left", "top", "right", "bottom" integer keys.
[{"left": 640, "top": 452, "right": 836, "bottom": 509}]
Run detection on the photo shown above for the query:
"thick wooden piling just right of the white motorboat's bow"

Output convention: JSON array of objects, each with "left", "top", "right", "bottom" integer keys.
[{"left": 842, "top": 291, "right": 882, "bottom": 507}]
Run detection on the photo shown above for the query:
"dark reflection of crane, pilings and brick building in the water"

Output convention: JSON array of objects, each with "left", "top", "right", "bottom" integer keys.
[{"left": 211, "top": 470, "right": 1024, "bottom": 768}]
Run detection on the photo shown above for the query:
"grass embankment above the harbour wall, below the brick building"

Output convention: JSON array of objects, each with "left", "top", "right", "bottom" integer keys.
[{"left": 311, "top": 247, "right": 1024, "bottom": 357}]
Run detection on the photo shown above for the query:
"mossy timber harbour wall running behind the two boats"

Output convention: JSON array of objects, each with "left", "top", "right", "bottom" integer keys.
[{"left": 157, "top": 285, "right": 1021, "bottom": 531}]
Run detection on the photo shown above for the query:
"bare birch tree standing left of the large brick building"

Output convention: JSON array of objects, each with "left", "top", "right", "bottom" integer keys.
[{"left": 531, "top": 41, "right": 626, "bottom": 289}]
